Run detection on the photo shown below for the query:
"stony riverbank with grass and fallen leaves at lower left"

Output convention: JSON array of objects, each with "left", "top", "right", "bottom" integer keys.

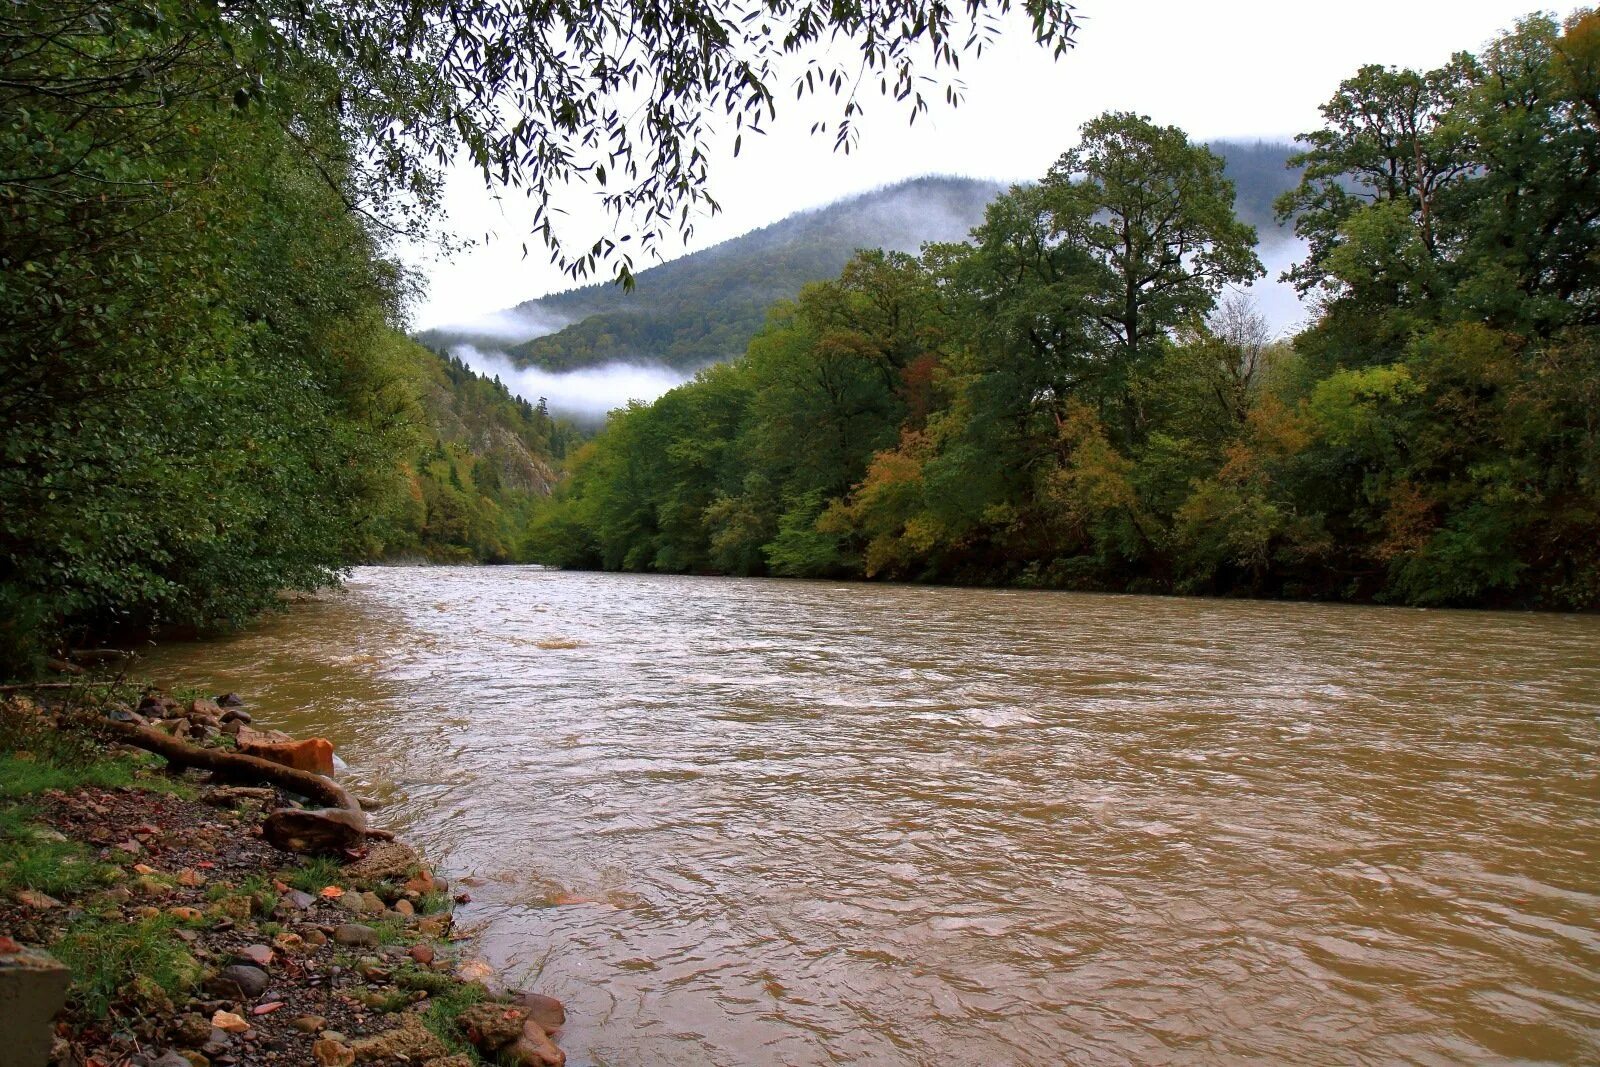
[{"left": 0, "top": 691, "right": 565, "bottom": 1067}]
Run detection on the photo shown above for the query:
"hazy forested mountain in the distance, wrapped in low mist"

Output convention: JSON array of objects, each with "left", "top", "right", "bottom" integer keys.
[{"left": 419, "top": 142, "right": 1294, "bottom": 371}]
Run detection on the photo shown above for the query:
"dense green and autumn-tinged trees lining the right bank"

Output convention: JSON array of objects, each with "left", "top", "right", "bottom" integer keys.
[{"left": 525, "top": 13, "right": 1600, "bottom": 609}]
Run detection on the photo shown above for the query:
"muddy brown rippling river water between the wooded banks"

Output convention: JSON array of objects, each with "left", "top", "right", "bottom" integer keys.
[{"left": 147, "top": 568, "right": 1600, "bottom": 1067}]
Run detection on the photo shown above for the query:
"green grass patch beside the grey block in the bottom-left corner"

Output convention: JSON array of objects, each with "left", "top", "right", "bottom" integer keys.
[{"left": 51, "top": 915, "right": 203, "bottom": 1019}]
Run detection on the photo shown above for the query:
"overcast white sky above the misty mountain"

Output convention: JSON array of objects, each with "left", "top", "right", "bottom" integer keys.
[{"left": 414, "top": 0, "right": 1576, "bottom": 326}]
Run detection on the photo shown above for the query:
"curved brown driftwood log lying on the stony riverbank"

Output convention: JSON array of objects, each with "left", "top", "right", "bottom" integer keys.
[{"left": 94, "top": 720, "right": 394, "bottom": 853}]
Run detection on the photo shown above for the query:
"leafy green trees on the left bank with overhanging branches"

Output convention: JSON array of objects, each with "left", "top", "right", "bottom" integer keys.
[{"left": 9, "top": 0, "right": 1075, "bottom": 677}]
